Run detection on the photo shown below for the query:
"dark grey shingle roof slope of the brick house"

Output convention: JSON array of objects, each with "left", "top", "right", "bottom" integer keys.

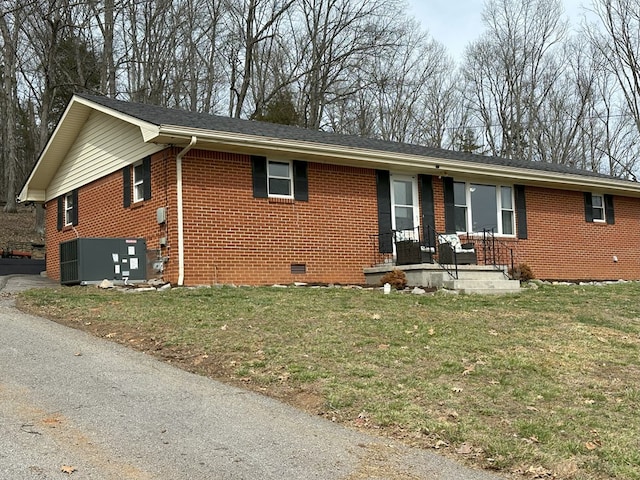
[{"left": 78, "top": 94, "right": 616, "bottom": 179}]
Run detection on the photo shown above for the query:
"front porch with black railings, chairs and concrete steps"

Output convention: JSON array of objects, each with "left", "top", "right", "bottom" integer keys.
[{"left": 364, "top": 227, "right": 520, "bottom": 294}]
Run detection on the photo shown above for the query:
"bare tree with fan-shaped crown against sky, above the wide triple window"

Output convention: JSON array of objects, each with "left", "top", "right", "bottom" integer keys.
[{"left": 464, "top": 0, "right": 566, "bottom": 160}]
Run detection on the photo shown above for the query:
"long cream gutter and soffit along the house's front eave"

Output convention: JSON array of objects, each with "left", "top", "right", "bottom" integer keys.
[{"left": 160, "top": 125, "right": 640, "bottom": 197}]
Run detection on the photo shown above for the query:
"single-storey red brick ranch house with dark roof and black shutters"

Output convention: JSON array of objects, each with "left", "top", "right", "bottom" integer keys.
[{"left": 19, "top": 95, "right": 640, "bottom": 285}]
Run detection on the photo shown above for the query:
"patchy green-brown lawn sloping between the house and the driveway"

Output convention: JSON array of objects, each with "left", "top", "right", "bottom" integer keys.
[{"left": 20, "top": 283, "right": 640, "bottom": 480}]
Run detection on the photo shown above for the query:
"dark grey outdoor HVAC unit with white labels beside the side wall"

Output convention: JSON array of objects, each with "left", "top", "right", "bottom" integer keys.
[{"left": 60, "top": 238, "right": 147, "bottom": 285}]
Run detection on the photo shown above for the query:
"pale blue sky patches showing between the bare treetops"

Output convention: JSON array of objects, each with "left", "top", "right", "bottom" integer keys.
[{"left": 408, "top": 0, "right": 590, "bottom": 60}]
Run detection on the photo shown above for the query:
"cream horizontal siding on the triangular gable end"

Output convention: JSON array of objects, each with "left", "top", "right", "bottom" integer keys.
[{"left": 46, "top": 111, "right": 165, "bottom": 200}]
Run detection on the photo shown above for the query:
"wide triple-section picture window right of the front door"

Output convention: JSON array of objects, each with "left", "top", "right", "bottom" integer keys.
[{"left": 453, "top": 182, "right": 515, "bottom": 235}]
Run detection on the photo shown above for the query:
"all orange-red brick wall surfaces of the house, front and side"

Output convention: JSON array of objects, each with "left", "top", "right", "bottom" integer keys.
[{"left": 46, "top": 149, "right": 640, "bottom": 285}]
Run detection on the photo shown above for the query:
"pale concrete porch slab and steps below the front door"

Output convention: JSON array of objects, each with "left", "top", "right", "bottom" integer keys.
[{"left": 364, "top": 263, "right": 520, "bottom": 295}]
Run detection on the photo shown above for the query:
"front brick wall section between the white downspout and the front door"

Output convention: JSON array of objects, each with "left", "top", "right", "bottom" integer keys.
[{"left": 183, "top": 150, "right": 377, "bottom": 284}]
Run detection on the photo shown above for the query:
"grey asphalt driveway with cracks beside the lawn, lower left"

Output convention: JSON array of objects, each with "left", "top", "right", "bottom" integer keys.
[{"left": 0, "top": 276, "right": 504, "bottom": 480}]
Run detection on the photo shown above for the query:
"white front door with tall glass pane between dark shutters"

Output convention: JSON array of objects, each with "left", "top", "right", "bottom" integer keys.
[{"left": 391, "top": 174, "right": 420, "bottom": 240}]
